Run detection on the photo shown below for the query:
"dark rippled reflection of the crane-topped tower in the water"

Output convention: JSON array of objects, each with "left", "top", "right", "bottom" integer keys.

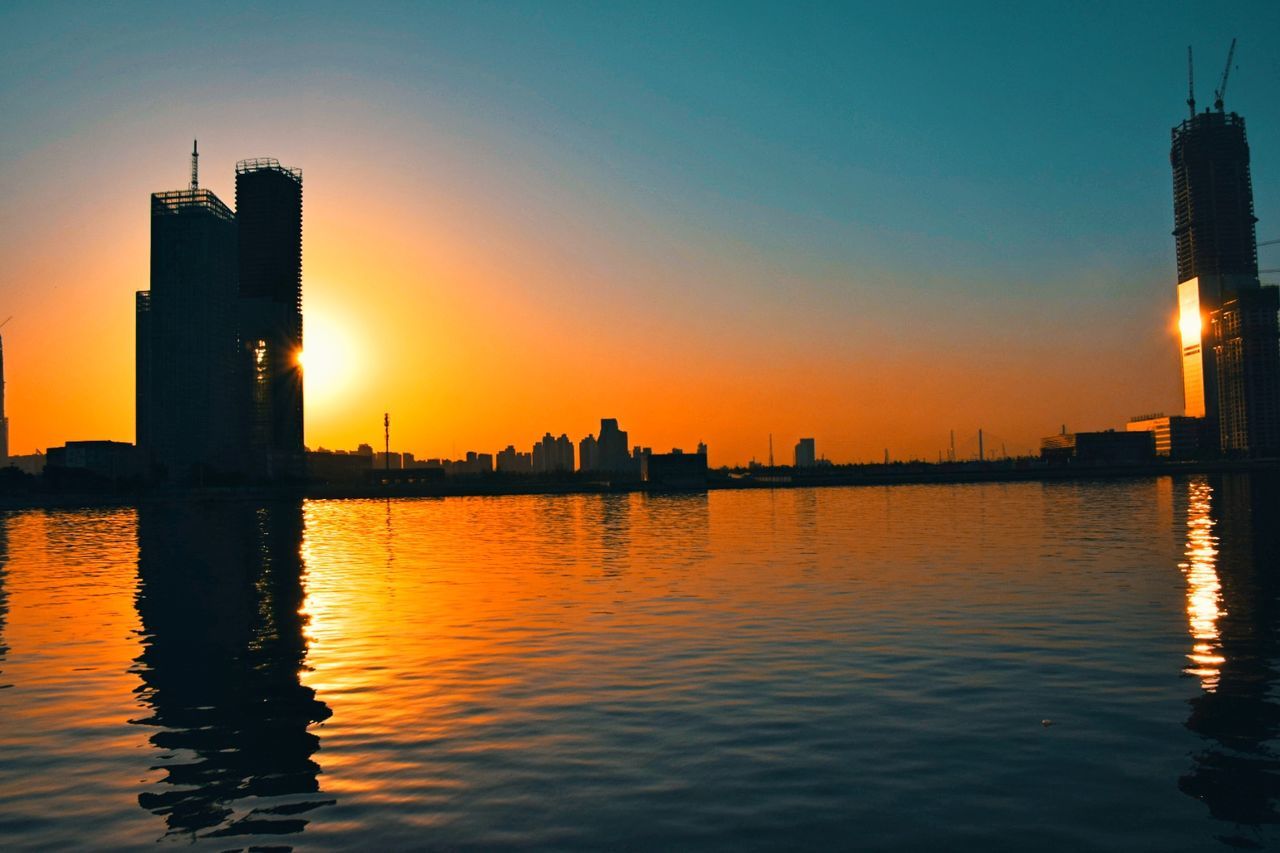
[{"left": 1178, "top": 473, "right": 1280, "bottom": 824}]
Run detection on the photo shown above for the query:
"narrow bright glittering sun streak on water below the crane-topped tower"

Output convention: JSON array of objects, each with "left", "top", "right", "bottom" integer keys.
[{"left": 1178, "top": 479, "right": 1226, "bottom": 693}]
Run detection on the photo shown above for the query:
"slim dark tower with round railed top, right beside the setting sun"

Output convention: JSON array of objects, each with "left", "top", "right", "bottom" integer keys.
[{"left": 236, "top": 159, "right": 305, "bottom": 479}]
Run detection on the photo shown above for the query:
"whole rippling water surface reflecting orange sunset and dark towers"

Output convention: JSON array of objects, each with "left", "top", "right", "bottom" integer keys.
[{"left": 0, "top": 475, "right": 1280, "bottom": 850}]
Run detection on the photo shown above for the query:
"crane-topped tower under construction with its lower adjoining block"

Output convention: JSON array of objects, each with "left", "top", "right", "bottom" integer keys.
[{"left": 1170, "top": 42, "right": 1280, "bottom": 455}]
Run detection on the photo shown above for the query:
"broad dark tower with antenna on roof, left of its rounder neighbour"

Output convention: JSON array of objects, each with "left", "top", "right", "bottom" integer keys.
[{"left": 136, "top": 163, "right": 237, "bottom": 482}]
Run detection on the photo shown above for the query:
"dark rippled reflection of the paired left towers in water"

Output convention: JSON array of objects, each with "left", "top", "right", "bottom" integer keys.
[{"left": 133, "top": 503, "right": 332, "bottom": 836}]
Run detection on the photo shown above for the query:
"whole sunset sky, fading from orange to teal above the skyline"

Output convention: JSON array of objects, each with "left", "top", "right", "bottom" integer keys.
[{"left": 0, "top": 1, "right": 1280, "bottom": 465}]
